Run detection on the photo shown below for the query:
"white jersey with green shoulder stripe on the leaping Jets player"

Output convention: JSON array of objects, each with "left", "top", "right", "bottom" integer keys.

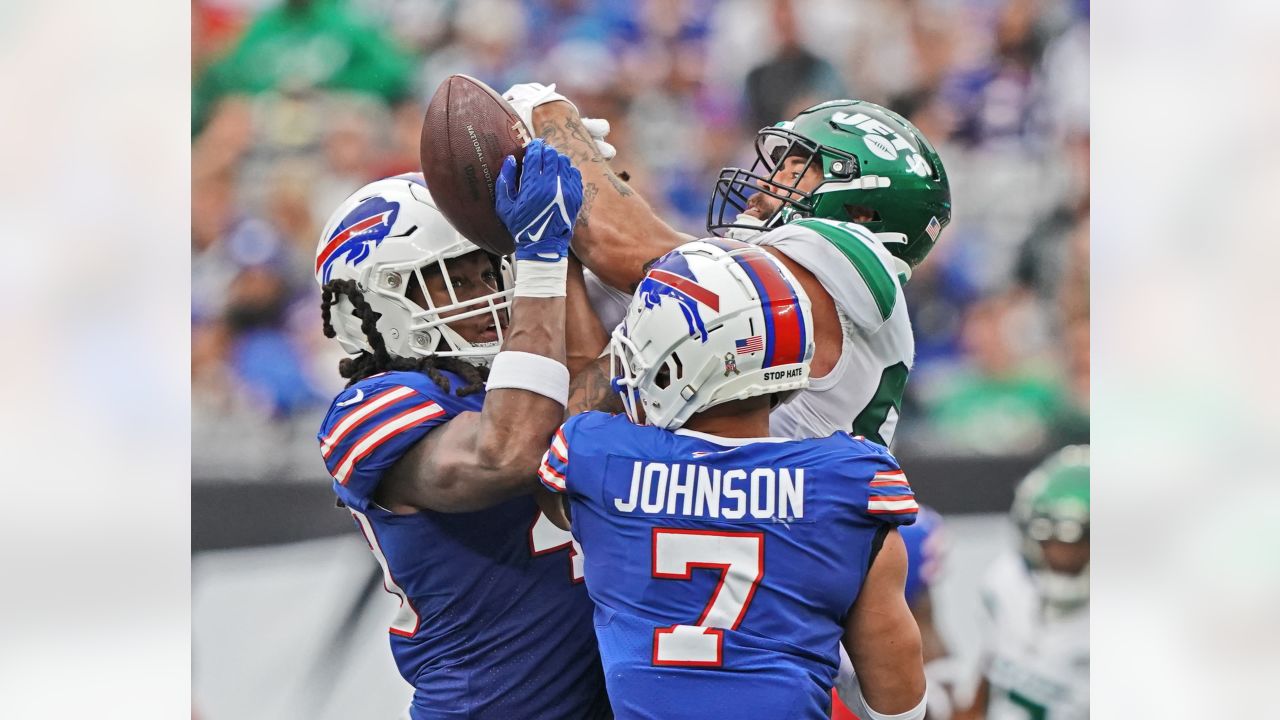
[{"left": 584, "top": 219, "right": 915, "bottom": 446}]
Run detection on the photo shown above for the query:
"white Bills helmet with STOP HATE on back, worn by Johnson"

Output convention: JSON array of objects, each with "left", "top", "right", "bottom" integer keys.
[{"left": 609, "top": 238, "right": 814, "bottom": 429}]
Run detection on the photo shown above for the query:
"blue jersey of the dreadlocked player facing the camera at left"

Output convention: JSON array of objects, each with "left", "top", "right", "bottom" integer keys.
[{"left": 316, "top": 372, "right": 609, "bottom": 720}]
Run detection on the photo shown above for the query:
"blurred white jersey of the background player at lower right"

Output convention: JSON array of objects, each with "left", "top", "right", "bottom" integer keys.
[{"left": 982, "top": 551, "right": 1089, "bottom": 720}]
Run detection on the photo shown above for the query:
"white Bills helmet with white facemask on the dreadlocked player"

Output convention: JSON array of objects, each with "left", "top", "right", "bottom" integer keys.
[{"left": 315, "top": 173, "right": 512, "bottom": 365}]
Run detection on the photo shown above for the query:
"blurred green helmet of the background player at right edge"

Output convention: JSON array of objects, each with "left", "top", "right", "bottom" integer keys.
[{"left": 1012, "top": 445, "right": 1089, "bottom": 609}]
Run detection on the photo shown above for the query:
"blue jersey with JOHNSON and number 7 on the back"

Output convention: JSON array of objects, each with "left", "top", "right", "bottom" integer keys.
[{"left": 539, "top": 413, "right": 916, "bottom": 720}]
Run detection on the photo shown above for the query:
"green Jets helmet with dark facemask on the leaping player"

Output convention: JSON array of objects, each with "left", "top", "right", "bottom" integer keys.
[{"left": 707, "top": 100, "right": 951, "bottom": 268}]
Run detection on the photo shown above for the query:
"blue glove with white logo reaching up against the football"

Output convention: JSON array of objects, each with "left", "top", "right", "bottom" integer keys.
[{"left": 494, "top": 138, "right": 582, "bottom": 263}]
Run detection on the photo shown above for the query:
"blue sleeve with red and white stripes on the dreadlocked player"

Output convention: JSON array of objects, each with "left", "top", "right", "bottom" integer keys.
[{"left": 316, "top": 384, "right": 449, "bottom": 511}]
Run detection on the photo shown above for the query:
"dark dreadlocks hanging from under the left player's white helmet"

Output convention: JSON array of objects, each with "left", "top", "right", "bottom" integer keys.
[{"left": 320, "top": 279, "right": 489, "bottom": 397}]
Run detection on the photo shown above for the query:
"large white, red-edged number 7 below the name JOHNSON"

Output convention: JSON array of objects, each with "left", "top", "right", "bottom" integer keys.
[{"left": 653, "top": 528, "right": 764, "bottom": 667}]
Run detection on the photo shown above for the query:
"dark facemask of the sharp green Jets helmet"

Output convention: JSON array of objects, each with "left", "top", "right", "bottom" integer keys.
[{"left": 707, "top": 127, "right": 859, "bottom": 240}]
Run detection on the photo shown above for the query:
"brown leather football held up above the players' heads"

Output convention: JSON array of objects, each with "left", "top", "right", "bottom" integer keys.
[{"left": 419, "top": 74, "right": 530, "bottom": 255}]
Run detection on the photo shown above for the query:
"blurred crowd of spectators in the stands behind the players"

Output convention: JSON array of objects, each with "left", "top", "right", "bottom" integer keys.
[{"left": 191, "top": 0, "right": 1089, "bottom": 478}]
